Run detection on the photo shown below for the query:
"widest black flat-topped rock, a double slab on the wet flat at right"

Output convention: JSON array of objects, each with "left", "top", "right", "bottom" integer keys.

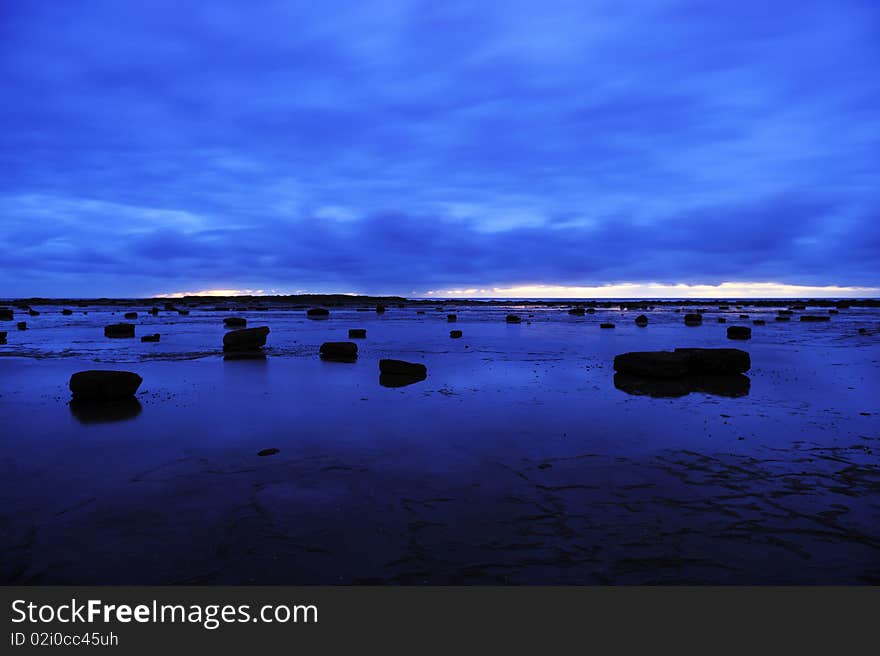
[{"left": 614, "top": 348, "right": 751, "bottom": 378}]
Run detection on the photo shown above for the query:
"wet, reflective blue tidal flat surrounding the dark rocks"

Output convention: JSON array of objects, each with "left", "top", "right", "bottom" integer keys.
[{"left": 0, "top": 303, "right": 880, "bottom": 584}]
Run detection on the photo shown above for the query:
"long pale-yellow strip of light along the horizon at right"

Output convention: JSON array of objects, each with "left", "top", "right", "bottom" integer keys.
[{"left": 424, "top": 282, "right": 880, "bottom": 298}]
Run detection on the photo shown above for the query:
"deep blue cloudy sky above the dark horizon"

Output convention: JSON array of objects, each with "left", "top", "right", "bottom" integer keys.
[{"left": 0, "top": 0, "right": 880, "bottom": 296}]
